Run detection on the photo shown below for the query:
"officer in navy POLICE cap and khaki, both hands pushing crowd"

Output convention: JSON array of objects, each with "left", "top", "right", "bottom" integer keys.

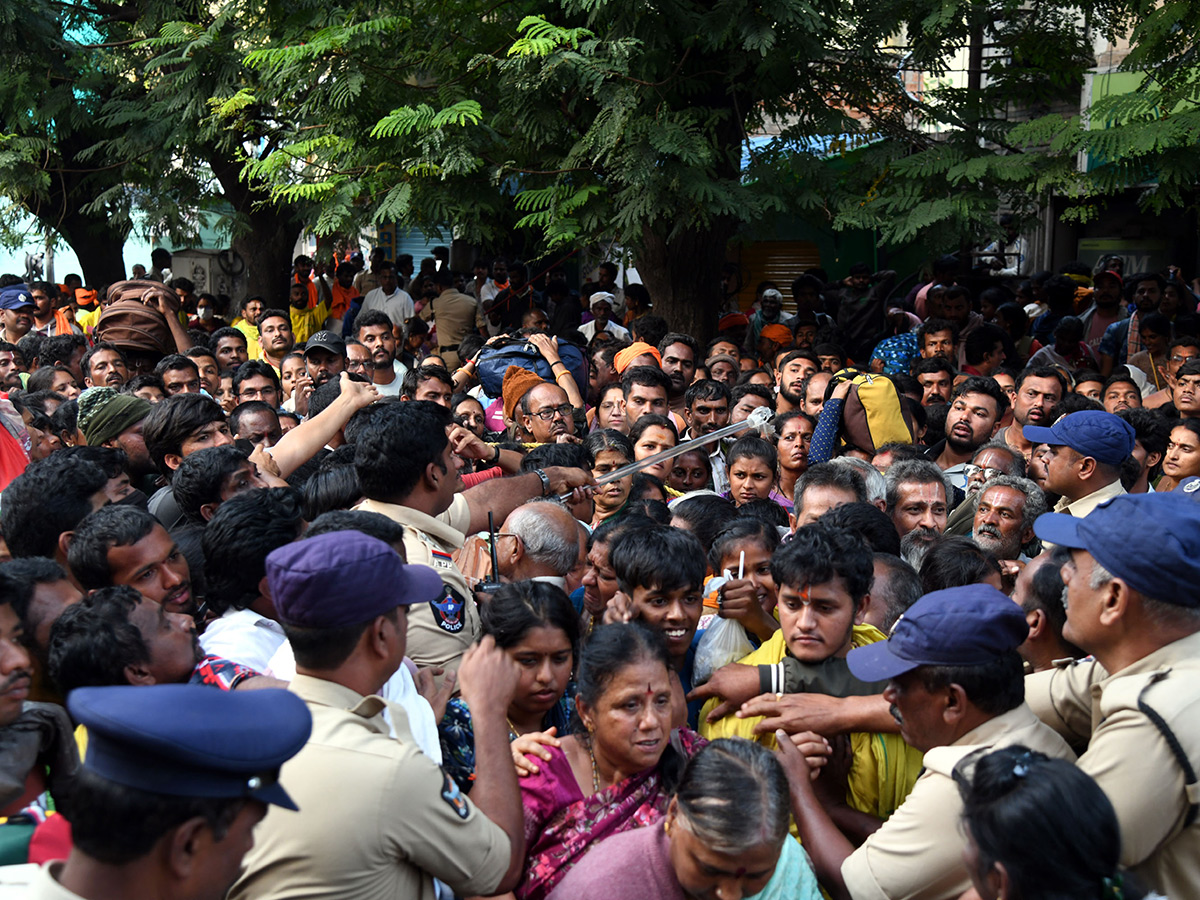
[{"left": 778, "top": 584, "right": 1074, "bottom": 900}]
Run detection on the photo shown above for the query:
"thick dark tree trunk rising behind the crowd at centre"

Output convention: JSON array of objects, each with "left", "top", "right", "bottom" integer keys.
[{"left": 634, "top": 220, "right": 737, "bottom": 343}]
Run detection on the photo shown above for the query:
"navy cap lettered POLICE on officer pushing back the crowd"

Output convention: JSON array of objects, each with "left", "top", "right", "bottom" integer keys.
[{"left": 846, "top": 584, "right": 1030, "bottom": 682}]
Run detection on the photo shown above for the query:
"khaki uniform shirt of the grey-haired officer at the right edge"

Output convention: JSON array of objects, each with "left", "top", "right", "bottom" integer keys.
[{"left": 1025, "top": 634, "right": 1200, "bottom": 898}]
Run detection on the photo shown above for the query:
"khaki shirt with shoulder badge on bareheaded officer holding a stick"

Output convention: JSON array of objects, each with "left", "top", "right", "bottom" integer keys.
[{"left": 355, "top": 493, "right": 481, "bottom": 668}]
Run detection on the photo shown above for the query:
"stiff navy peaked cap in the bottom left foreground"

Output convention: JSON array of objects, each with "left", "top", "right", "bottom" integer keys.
[{"left": 67, "top": 684, "right": 312, "bottom": 810}]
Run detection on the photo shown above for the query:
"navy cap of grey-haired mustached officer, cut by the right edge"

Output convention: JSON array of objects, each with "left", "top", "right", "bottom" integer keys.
[{"left": 1033, "top": 491, "right": 1200, "bottom": 607}]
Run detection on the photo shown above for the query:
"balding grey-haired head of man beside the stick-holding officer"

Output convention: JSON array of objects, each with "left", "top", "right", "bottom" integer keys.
[{"left": 497, "top": 502, "right": 580, "bottom": 581}]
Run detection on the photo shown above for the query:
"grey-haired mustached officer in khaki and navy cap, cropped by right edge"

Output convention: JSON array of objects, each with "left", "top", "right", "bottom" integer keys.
[{"left": 1026, "top": 492, "right": 1200, "bottom": 898}]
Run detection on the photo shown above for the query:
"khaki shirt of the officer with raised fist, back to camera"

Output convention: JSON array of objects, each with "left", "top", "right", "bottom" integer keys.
[{"left": 229, "top": 674, "right": 511, "bottom": 900}]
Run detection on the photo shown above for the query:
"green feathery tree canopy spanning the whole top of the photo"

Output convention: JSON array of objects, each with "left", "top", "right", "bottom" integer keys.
[{"left": 0, "top": 0, "right": 1200, "bottom": 331}]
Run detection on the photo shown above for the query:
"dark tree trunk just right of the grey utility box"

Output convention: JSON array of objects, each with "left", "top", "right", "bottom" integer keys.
[{"left": 209, "top": 150, "right": 304, "bottom": 310}]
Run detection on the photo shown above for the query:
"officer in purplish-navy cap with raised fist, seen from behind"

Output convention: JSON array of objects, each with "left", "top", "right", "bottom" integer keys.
[{"left": 229, "top": 532, "right": 524, "bottom": 900}]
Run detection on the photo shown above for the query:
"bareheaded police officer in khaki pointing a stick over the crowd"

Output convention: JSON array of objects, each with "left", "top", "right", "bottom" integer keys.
[{"left": 354, "top": 401, "right": 592, "bottom": 668}]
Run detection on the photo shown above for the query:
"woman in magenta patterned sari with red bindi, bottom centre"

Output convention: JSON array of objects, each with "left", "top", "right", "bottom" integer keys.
[{"left": 516, "top": 624, "right": 704, "bottom": 900}]
